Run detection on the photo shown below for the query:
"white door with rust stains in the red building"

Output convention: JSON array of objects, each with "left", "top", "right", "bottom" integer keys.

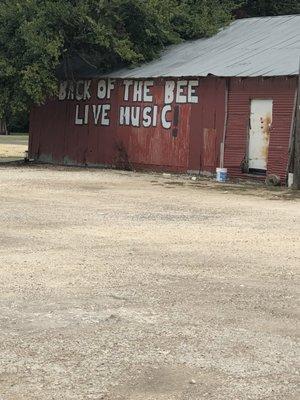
[{"left": 248, "top": 99, "right": 273, "bottom": 171}]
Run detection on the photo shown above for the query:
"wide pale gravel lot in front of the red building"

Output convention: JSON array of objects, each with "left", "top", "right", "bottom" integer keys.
[{"left": 0, "top": 163, "right": 300, "bottom": 400}]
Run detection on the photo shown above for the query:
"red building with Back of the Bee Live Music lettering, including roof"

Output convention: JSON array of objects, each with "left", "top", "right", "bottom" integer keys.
[{"left": 29, "top": 15, "right": 300, "bottom": 184}]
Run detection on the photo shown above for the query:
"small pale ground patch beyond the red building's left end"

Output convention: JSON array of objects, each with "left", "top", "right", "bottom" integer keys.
[{"left": 0, "top": 134, "right": 28, "bottom": 162}]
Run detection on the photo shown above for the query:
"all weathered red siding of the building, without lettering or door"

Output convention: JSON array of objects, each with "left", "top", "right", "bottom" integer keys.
[{"left": 29, "top": 77, "right": 296, "bottom": 182}]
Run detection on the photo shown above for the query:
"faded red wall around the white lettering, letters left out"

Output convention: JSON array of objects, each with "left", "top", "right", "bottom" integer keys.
[{"left": 29, "top": 79, "right": 198, "bottom": 172}]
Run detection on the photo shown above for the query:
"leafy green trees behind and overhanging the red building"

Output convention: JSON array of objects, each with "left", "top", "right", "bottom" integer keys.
[{"left": 0, "top": 0, "right": 240, "bottom": 131}]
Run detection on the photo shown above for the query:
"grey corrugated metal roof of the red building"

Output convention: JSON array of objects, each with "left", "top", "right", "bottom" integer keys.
[{"left": 109, "top": 15, "right": 300, "bottom": 78}]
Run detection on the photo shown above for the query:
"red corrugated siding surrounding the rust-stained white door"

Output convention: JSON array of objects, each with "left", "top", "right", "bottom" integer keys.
[{"left": 225, "top": 77, "right": 296, "bottom": 182}]
